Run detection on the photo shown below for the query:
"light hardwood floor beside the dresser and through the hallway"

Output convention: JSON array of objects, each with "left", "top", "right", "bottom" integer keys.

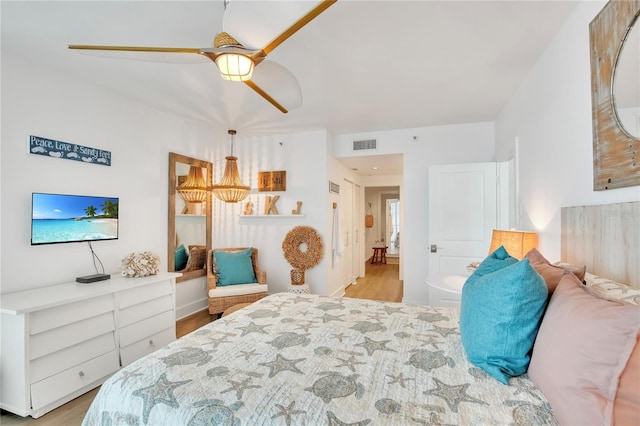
[{"left": 0, "top": 262, "right": 402, "bottom": 426}]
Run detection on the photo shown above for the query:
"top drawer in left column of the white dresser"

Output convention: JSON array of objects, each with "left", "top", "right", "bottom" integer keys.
[{"left": 29, "top": 294, "right": 115, "bottom": 335}]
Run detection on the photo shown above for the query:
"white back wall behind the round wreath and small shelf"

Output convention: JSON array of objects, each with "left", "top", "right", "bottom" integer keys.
[{"left": 213, "top": 131, "right": 331, "bottom": 295}]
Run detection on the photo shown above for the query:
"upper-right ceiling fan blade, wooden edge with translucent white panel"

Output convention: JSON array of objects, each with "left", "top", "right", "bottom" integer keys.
[{"left": 222, "top": 0, "right": 337, "bottom": 53}]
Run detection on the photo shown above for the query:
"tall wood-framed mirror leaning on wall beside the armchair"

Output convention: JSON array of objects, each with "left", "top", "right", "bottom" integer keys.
[{"left": 167, "top": 152, "right": 213, "bottom": 282}]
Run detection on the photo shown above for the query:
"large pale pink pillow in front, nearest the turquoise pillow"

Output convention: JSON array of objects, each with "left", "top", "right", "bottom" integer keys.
[{"left": 529, "top": 273, "right": 640, "bottom": 425}]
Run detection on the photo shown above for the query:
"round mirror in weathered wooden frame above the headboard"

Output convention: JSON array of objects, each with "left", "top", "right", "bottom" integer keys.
[{"left": 589, "top": 0, "right": 640, "bottom": 191}]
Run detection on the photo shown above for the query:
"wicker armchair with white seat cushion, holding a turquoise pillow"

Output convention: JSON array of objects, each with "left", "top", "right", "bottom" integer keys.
[{"left": 207, "top": 247, "right": 268, "bottom": 315}]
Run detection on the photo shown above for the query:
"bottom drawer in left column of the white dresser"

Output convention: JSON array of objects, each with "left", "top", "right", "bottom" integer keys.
[{"left": 31, "top": 351, "right": 119, "bottom": 410}]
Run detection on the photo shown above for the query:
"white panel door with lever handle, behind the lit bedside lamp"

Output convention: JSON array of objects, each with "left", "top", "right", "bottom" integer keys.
[{"left": 428, "top": 163, "right": 498, "bottom": 276}]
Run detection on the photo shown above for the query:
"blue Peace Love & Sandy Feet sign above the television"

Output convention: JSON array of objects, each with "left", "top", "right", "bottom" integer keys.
[{"left": 29, "top": 135, "right": 111, "bottom": 166}]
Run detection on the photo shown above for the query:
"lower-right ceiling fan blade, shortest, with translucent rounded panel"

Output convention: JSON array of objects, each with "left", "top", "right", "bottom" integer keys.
[{"left": 245, "top": 60, "right": 302, "bottom": 114}]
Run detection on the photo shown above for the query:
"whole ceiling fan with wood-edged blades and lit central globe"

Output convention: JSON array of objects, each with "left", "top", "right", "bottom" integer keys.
[{"left": 68, "top": 0, "right": 337, "bottom": 114}]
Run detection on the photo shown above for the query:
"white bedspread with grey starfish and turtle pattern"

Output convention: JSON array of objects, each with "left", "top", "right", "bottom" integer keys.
[{"left": 83, "top": 293, "right": 557, "bottom": 426}]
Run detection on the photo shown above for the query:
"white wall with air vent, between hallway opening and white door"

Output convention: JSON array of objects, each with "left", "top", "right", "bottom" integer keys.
[{"left": 334, "top": 123, "right": 495, "bottom": 303}]
